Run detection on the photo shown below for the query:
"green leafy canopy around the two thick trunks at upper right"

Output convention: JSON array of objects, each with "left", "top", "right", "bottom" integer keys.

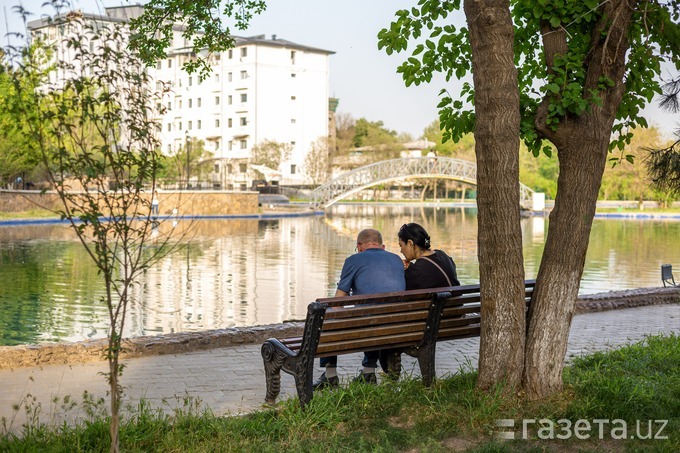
[{"left": 378, "top": 0, "right": 680, "bottom": 155}]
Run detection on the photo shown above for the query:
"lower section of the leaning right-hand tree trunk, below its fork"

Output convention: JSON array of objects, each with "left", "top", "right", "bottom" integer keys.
[{"left": 524, "top": 130, "right": 609, "bottom": 399}]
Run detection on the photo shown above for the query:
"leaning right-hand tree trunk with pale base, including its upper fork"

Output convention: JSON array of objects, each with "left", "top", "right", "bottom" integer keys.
[{"left": 523, "top": 0, "right": 632, "bottom": 399}]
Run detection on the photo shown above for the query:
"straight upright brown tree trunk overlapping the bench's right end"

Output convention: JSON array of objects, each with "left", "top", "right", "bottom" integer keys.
[{"left": 464, "top": 0, "right": 525, "bottom": 389}]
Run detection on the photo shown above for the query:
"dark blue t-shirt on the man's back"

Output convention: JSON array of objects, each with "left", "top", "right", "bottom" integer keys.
[{"left": 338, "top": 248, "right": 406, "bottom": 296}]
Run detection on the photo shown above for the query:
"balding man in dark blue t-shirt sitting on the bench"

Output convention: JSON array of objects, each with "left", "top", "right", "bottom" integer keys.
[{"left": 314, "top": 229, "right": 406, "bottom": 390}]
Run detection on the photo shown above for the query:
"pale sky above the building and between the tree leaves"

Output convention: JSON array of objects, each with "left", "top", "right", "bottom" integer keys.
[{"left": 0, "top": 0, "right": 680, "bottom": 138}]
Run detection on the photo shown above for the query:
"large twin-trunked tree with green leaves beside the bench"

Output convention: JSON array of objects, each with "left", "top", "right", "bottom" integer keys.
[{"left": 379, "top": 0, "right": 680, "bottom": 398}]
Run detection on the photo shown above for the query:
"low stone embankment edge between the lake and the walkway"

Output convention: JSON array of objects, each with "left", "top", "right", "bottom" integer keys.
[{"left": 0, "top": 288, "right": 680, "bottom": 369}]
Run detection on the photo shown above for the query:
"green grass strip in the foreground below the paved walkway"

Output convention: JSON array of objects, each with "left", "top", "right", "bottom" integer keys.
[{"left": 0, "top": 335, "right": 680, "bottom": 452}]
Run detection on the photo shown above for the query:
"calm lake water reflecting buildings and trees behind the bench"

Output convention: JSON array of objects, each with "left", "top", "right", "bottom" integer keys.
[{"left": 0, "top": 205, "right": 680, "bottom": 345}]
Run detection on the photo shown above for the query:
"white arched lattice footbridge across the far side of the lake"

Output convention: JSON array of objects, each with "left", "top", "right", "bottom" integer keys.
[{"left": 312, "top": 157, "right": 534, "bottom": 209}]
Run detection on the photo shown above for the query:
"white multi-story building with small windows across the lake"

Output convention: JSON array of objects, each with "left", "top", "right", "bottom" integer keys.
[{"left": 28, "top": 6, "right": 334, "bottom": 189}]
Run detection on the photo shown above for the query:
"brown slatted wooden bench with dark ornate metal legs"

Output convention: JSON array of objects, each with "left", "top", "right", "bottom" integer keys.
[{"left": 262, "top": 280, "right": 535, "bottom": 407}]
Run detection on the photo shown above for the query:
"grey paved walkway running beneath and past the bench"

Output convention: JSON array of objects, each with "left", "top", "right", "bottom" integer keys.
[{"left": 0, "top": 304, "right": 680, "bottom": 432}]
